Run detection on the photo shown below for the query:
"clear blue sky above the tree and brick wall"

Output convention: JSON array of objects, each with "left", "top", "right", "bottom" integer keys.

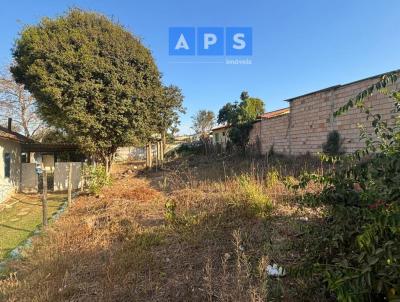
[{"left": 0, "top": 0, "right": 400, "bottom": 134}]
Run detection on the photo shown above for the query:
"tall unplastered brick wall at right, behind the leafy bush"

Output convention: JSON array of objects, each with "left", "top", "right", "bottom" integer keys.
[{"left": 251, "top": 77, "right": 400, "bottom": 154}]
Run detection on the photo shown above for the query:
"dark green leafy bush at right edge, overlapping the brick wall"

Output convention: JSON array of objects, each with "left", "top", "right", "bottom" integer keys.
[{"left": 290, "top": 73, "right": 400, "bottom": 301}]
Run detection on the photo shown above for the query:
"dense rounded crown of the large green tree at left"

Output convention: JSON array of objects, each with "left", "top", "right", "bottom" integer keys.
[{"left": 11, "top": 9, "right": 163, "bottom": 169}]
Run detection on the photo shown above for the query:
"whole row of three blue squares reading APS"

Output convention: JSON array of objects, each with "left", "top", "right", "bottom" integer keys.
[{"left": 169, "top": 27, "right": 253, "bottom": 56}]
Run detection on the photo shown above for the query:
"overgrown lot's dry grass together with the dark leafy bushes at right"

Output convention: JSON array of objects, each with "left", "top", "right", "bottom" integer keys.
[{"left": 0, "top": 74, "right": 400, "bottom": 301}]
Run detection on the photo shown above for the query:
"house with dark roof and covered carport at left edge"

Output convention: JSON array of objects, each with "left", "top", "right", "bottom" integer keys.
[{"left": 0, "top": 118, "right": 83, "bottom": 202}]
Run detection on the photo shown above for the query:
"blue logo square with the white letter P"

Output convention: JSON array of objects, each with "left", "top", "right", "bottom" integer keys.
[{"left": 197, "top": 27, "right": 225, "bottom": 56}]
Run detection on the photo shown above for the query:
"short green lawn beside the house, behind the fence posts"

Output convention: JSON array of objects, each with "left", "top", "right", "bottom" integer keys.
[{"left": 0, "top": 194, "right": 66, "bottom": 261}]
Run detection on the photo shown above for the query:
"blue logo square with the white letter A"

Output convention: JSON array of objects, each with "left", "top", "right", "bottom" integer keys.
[{"left": 169, "top": 27, "right": 196, "bottom": 56}]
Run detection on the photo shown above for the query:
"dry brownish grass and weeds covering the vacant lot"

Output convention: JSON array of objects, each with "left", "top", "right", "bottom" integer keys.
[{"left": 0, "top": 158, "right": 330, "bottom": 301}]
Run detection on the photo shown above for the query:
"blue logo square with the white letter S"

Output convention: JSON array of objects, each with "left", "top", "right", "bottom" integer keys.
[{"left": 226, "top": 27, "right": 253, "bottom": 56}]
